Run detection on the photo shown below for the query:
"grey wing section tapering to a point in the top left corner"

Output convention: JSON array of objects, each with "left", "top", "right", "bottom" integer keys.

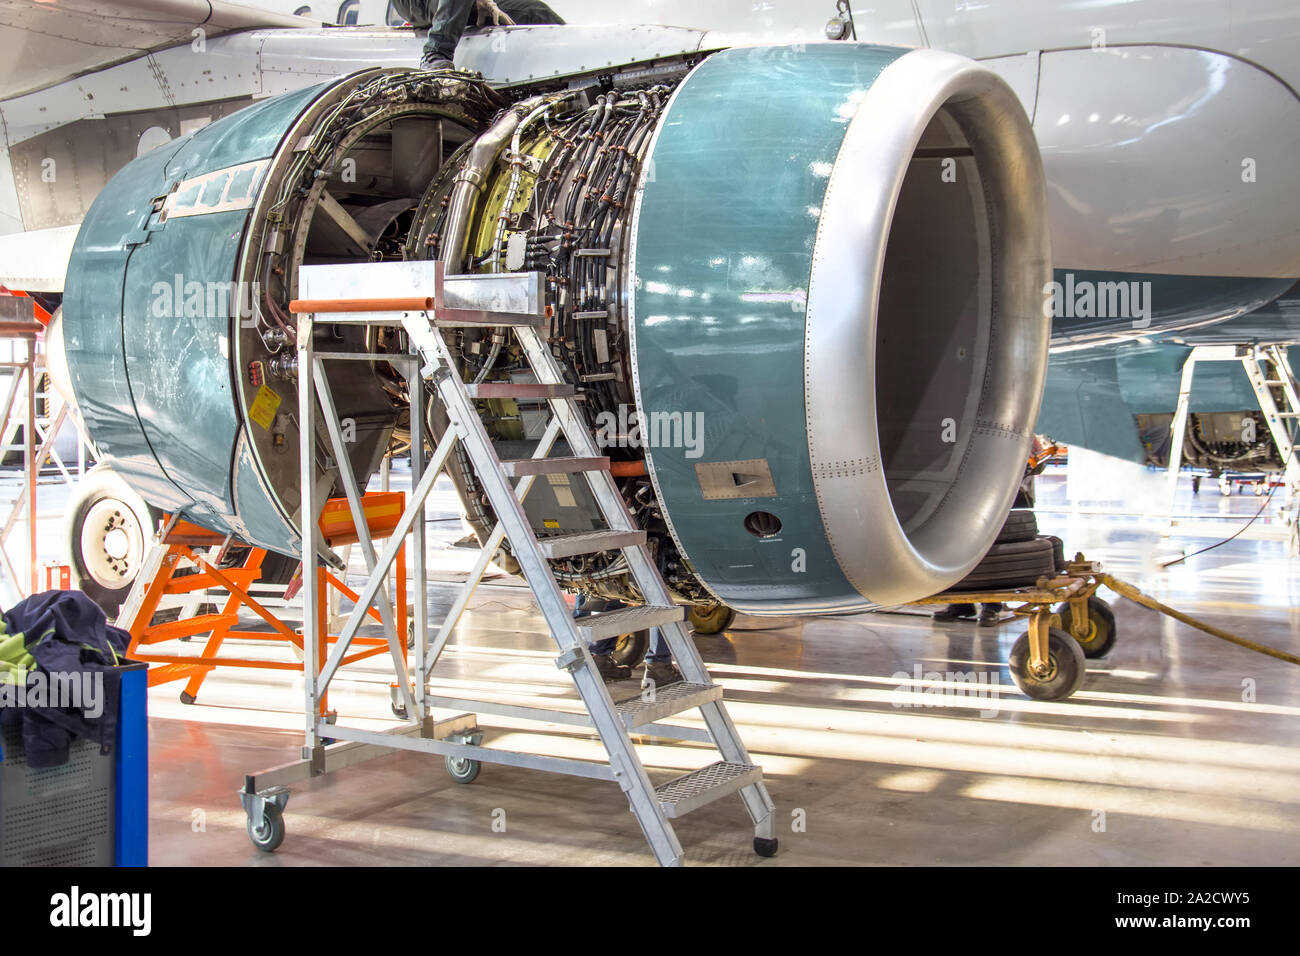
[{"left": 0, "top": 0, "right": 309, "bottom": 100}]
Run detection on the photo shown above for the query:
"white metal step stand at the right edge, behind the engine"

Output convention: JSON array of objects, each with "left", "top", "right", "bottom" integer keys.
[{"left": 1167, "top": 343, "right": 1300, "bottom": 557}]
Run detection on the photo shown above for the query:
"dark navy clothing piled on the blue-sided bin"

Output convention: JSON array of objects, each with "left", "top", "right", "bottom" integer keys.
[{"left": 0, "top": 591, "right": 130, "bottom": 767}]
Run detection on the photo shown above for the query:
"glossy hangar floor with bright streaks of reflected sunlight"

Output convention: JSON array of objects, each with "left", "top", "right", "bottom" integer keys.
[{"left": 32, "top": 463, "right": 1300, "bottom": 866}]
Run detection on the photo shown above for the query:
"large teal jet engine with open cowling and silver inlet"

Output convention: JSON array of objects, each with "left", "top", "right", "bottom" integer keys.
[{"left": 64, "top": 43, "right": 1050, "bottom": 614}]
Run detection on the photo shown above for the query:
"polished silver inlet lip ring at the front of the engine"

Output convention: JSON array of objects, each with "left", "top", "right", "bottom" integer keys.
[{"left": 803, "top": 49, "right": 1052, "bottom": 605}]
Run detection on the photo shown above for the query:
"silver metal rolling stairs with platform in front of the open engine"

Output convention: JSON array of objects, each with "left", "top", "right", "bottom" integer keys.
[{"left": 241, "top": 261, "right": 777, "bottom": 865}]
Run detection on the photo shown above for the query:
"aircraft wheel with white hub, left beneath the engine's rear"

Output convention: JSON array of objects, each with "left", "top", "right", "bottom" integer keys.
[{"left": 64, "top": 464, "right": 153, "bottom": 622}]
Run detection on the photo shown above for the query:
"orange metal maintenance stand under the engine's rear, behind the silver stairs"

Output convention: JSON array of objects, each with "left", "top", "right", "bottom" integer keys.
[{"left": 117, "top": 492, "right": 407, "bottom": 715}]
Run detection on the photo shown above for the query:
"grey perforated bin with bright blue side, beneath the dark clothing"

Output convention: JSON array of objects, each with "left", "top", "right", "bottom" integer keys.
[{"left": 0, "top": 663, "right": 150, "bottom": 866}]
